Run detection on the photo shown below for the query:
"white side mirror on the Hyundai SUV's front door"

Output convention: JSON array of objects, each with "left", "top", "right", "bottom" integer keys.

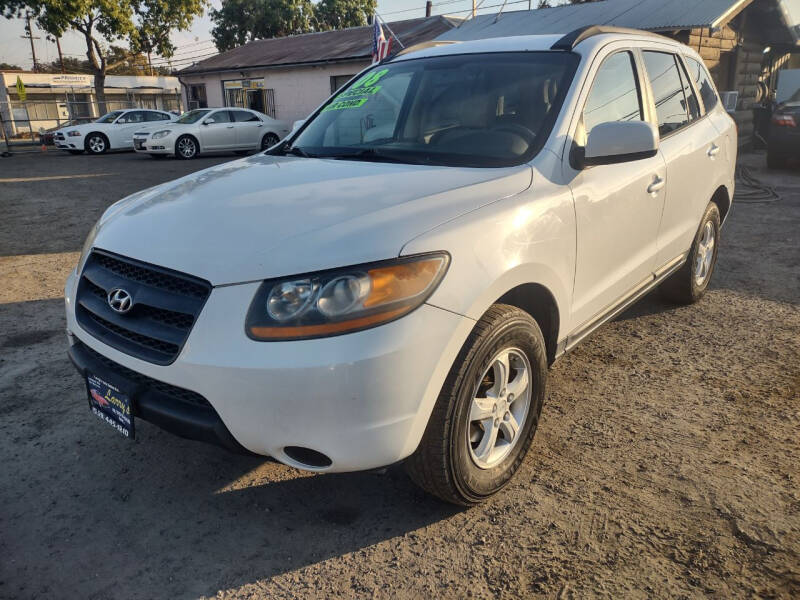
[{"left": 582, "top": 121, "right": 659, "bottom": 166}]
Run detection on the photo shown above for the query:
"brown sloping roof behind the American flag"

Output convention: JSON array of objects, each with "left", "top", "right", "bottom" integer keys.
[{"left": 179, "top": 15, "right": 462, "bottom": 75}]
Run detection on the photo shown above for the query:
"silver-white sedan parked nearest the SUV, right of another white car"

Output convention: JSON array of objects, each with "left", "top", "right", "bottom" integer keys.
[{"left": 133, "top": 108, "right": 290, "bottom": 159}]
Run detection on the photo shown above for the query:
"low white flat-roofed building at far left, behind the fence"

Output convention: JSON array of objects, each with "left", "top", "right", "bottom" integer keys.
[{"left": 0, "top": 71, "right": 181, "bottom": 138}]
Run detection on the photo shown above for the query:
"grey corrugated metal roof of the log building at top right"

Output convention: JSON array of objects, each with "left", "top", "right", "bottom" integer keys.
[{"left": 437, "top": 0, "right": 800, "bottom": 41}]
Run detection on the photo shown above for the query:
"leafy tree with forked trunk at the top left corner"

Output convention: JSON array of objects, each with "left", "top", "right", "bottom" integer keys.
[{"left": 0, "top": 0, "right": 207, "bottom": 113}]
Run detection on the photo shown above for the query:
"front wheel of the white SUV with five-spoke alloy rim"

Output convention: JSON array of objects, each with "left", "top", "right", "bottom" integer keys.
[{"left": 405, "top": 304, "right": 547, "bottom": 506}]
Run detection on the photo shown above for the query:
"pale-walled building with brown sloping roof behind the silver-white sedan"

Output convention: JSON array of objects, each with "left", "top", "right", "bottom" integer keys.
[{"left": 178, "top": 16, "right": 461, "bottom": 121}]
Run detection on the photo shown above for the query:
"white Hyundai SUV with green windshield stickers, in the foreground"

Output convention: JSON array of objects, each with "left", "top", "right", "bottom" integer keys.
[{"left": 66, "top": 27, "right": 737, "bottom": 505}]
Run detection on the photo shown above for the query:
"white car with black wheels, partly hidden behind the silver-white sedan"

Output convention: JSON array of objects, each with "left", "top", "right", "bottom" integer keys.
[{"left": 53, "top": 108, "right": 177, "bottom": 154}]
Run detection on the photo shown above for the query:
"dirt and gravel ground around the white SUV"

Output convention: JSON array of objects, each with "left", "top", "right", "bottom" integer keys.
[{"left": 0, "top": 146, "right": 800, "bottom": 599}]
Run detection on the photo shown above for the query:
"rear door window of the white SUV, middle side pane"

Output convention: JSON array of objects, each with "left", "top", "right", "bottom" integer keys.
[{"left": 642, "top": 51, "right": 689, "bottom": 136}]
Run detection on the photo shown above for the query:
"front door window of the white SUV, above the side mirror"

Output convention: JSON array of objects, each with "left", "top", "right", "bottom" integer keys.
[{"left": 583, "top": 52, "right": 642, "bottom": 136}]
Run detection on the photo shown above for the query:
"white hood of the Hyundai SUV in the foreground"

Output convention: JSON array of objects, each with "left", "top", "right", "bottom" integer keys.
[{"left": 94, "top": 154, "right": 531, "bottom": 285}]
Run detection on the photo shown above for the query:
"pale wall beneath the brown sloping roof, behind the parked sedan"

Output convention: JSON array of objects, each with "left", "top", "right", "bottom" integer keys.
[{"left": 180, "top": 61, "right": 369, "bottom": 121}]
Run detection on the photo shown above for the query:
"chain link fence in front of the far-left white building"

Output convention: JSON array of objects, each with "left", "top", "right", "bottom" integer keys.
[{"left": 0, "top": 94, "right": 181, "bottom": 152}]
